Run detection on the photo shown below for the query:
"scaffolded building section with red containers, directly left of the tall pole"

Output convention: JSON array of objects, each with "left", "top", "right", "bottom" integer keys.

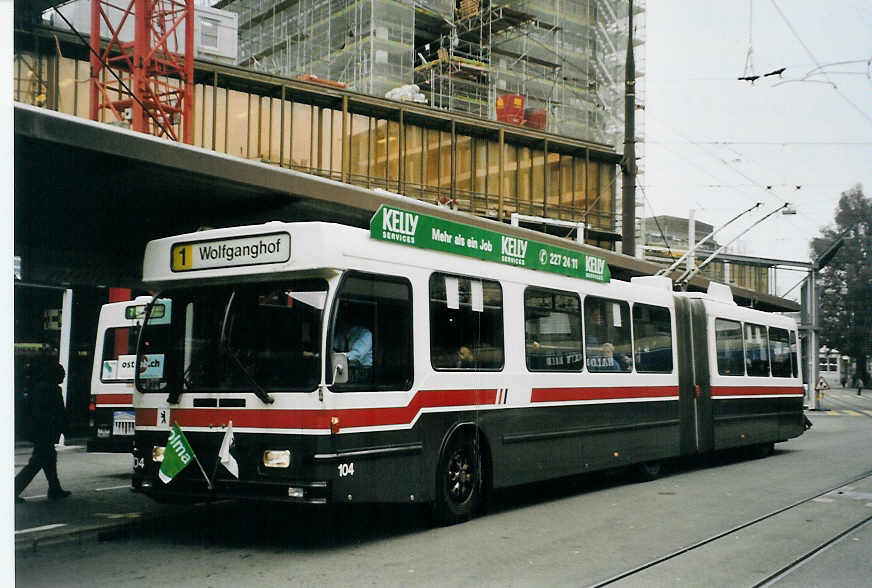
[{"left": 415, "top": 0, "right": 644, "bottom": 144}]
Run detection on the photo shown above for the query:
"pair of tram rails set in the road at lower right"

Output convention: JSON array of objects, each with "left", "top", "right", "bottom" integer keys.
[{"left": 589, "top": 470, "right": 872, "bottom": 588}]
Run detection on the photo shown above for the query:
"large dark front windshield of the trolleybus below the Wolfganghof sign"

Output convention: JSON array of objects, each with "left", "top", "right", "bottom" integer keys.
[{"left": 137, "top": 279, "right": 327, "bottom": 398}]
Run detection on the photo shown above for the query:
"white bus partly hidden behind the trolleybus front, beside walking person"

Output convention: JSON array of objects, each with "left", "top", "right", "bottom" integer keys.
[{"left": 88, "top": 296, "right": 169, "bottom": 453}]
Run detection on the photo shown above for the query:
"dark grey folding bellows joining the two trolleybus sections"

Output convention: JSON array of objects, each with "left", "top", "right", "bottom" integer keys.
[{"left": 675, "top": 298, "right": 714, "bottom": 455}]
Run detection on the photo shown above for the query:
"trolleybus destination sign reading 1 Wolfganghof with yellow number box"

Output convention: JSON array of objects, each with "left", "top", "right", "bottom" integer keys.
[{"left": 170, "top": 233, "right": 291, "bottom": 272}]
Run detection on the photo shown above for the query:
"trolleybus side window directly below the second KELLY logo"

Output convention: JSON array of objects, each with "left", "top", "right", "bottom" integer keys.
[{"left": 524, "top": 288, "right": 583, "bottom": 372}]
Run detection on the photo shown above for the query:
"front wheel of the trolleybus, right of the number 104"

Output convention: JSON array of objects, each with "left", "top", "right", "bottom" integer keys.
[{"left": 433, "top": 432, "right": 483, "bottom": 525}]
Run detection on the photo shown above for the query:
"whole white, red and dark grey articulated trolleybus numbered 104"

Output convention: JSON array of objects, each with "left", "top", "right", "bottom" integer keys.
[{"left": 133, "top": 205, "right": 804, "bottom": 523}]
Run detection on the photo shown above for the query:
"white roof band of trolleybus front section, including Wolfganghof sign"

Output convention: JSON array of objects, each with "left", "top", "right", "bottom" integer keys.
[{"left": 143, "top": 221, "right": 672, "bottom": 306}]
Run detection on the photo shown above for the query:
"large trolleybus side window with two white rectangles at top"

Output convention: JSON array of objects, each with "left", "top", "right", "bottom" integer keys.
[{"left": 430, "top": 273, "right": 503, "bottom": 371}]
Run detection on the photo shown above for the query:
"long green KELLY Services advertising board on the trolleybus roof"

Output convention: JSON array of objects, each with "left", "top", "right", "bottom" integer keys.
[{"left": 369, "top": 204, "right": 611, "bottom": 282}]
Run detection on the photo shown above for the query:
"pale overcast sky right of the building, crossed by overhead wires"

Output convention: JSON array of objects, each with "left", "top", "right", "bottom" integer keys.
[{"left": 637, "top": 0, "right": 872, "bottom": 297}]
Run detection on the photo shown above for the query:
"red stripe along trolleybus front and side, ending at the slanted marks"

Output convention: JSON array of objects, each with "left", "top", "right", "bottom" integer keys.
[{"left": 136, "top": 389, "right": 497, "bottom": 429}]
